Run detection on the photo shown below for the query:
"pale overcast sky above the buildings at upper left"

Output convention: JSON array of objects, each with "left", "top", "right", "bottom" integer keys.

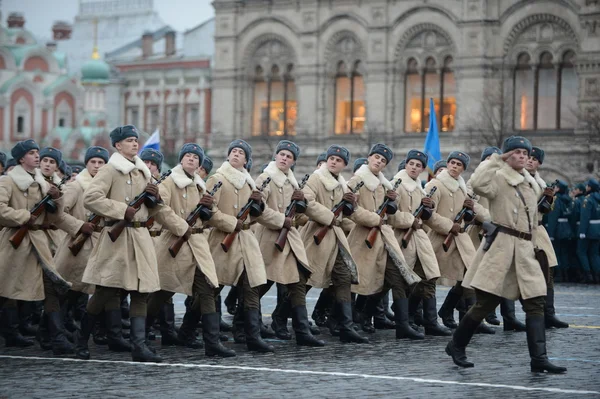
[{"left": 0, "top": 0, "right": 215, "bottom": 39}]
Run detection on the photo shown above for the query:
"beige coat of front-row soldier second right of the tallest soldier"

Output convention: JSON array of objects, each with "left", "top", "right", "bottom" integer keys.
[{"left": 206, "top": 161, "right": 267, "bottom": 287}]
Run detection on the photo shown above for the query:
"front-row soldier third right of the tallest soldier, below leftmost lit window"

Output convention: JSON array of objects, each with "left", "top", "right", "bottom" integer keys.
[{"left": 255, "top": 140, "right": 325, "bottom": 346}]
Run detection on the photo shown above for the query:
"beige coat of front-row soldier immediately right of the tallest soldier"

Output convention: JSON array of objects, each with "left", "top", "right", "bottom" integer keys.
[{"left": 155, "top": 165, "right": 219, "bottom": 295}]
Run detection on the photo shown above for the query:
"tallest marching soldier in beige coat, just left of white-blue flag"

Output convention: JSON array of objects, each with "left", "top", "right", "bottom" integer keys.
[{"left": 78, "top": 125, "right": 169, "bottom": 362}]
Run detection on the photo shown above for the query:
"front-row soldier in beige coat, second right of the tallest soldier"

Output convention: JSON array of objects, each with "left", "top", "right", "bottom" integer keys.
[{"left": 206, "top": 140, "right": 274, "bottom": 352}]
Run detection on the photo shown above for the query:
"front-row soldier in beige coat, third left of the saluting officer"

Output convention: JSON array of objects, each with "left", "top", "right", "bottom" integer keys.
[{"left": 348, "top": 144, "right": 424, "bottom": 339}]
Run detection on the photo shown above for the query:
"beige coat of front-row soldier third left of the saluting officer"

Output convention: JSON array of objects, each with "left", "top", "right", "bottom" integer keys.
[{"left": 348, "top": 165, "right": 421, "bottom": 295}]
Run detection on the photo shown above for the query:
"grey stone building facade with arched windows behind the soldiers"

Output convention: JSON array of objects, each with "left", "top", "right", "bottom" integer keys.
[{"left": 210, "top": 0, "right": 600, "bottom": 182}]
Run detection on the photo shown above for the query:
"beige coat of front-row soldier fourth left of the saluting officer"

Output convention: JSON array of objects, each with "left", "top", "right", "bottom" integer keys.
[{"left": 300, "top": 163, "right": 359, "bottom": 288}]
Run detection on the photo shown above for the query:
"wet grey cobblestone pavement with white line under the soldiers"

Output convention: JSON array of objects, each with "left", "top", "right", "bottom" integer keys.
[{"left": 0, "top": 284, "right": 600, "bottom": 398}]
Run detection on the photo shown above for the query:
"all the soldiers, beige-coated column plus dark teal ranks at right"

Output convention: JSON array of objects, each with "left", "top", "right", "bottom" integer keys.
[{"left": 0, "top": 125, "right": 600, "bottom": 373}]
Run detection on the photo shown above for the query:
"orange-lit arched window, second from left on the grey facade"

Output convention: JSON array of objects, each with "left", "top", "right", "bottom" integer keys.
[{"left": 334, "top": 61, "right": 366, "bottom": 134}]
